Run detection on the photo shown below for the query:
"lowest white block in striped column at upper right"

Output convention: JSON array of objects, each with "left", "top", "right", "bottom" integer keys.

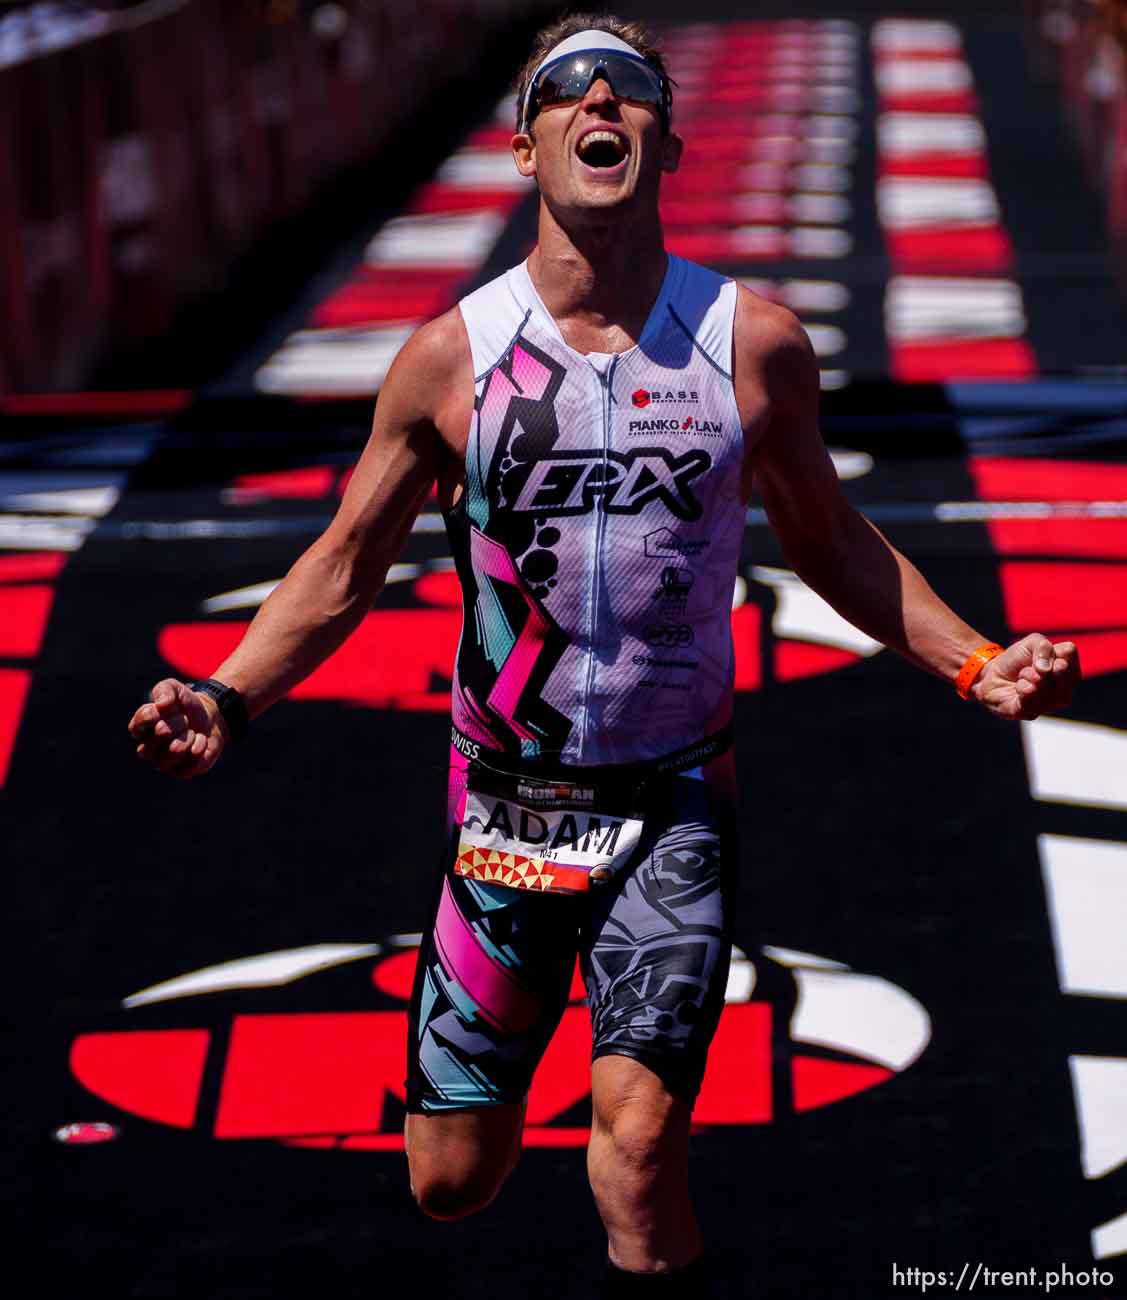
[{"left": 884, "top": 276, "right": 1026, "bottom": 342}]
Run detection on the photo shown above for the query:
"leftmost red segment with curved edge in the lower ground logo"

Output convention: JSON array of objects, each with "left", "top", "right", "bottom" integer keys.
[{"left": 70, "top": 1030, "right": 211, "bottom": 1128}]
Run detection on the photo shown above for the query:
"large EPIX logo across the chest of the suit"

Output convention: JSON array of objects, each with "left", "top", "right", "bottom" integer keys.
[{"left": 512, "top": 447, "right": 712, "bottom": 519}]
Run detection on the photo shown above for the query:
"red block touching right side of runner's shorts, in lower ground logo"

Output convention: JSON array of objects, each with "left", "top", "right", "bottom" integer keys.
[{"left": 693, "top": 1002, "right": 772, "bottom": 1125}]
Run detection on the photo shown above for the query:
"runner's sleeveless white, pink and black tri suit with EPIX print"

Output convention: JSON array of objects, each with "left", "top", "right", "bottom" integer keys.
[{"left": 408, "top": 256, "right": 745, "bottom": 1112}]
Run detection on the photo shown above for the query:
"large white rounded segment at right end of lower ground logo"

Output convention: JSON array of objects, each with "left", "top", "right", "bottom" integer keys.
[{"left": 790, "top": 966, "right": 931, "bottom": 1070}]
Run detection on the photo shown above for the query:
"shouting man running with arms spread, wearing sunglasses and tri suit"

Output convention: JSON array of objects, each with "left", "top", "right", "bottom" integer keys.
[{"left": 130, "top": 16, "right": 1079, "bottom": 1296}]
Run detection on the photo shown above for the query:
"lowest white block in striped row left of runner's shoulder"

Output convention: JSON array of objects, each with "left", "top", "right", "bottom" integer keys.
[{"left": 255, "top": 321, "right": 417, "bottom": 395}]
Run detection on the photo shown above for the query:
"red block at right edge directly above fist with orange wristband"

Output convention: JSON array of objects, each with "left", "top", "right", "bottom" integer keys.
[{"left": 1000, "top": 560, "right": 1127, "bottom": 631}]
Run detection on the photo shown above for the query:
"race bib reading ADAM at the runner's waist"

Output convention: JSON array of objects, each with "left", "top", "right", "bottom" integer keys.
[{"left": 454, "top": 764, "right": 643, "bottom": 893}]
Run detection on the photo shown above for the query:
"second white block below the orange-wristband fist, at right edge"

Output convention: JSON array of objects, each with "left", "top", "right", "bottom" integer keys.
[{"left": 1037, "top": 835, "right": 1127, "bottom": 997}]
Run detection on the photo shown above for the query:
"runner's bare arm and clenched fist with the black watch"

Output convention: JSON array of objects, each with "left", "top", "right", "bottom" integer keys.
[{"left": 130, "top": 304, "right": 473, "bottom": 776}]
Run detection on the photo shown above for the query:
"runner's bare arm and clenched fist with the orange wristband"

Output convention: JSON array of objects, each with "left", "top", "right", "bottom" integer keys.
[{"left": 736, "top": 293, "right": 1079, "bottom": 718}]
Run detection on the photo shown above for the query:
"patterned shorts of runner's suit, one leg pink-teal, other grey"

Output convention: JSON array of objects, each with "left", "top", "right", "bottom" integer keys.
[{"left": 407, "top": 751, "right": 736, "bottom": 1113}]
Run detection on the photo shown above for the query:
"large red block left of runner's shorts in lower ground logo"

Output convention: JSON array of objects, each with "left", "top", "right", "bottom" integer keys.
[{"left": 216, "top": 1011, "right": 407, "bottom": 1138}]
